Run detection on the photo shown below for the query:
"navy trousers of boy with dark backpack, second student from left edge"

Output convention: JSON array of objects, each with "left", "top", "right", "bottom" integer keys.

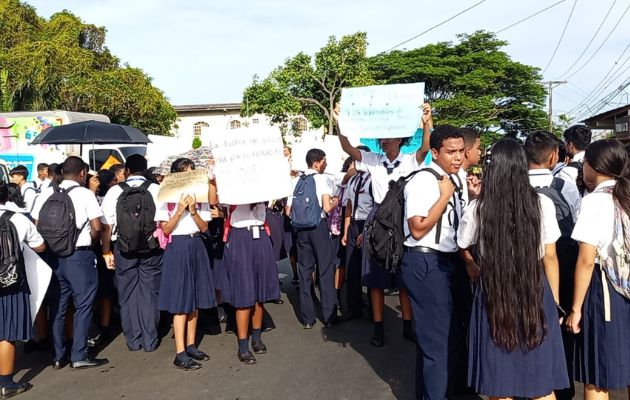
[{"left": 50, "top": 250, "right": 98, "bottom": 362}]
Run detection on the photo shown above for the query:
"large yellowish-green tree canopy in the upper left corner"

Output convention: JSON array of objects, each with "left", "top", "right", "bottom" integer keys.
[{"left": 0, "top": 0, "right": 177, "bottom": 134}]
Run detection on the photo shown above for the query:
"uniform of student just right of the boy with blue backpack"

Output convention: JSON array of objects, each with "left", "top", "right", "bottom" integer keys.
[{"left": 343, "top": 171, "right": 374, "bottom": 315}]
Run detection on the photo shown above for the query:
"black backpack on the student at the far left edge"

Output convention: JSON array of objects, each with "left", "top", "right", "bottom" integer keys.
[{"left": 0, "top": 211, "right": 26, "bottom": 295}]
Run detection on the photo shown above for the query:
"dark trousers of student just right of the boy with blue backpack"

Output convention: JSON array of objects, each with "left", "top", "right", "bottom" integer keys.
[{"left": 346, "top": 220, "right": 365, "bottom": 314}]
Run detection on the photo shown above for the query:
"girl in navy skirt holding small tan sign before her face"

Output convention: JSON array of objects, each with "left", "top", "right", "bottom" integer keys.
[{"left": 155, "top": 158, "right": 216, "bottom": 370}]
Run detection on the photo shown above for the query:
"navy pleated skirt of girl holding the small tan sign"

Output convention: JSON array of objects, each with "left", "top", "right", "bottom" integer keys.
[{"left": 158, "top": 235, "right": 217, "bottom": 314}]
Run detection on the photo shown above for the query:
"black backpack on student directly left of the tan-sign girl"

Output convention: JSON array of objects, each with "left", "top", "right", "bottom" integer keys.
[{"left": 116, "top": 181, "right": 160, "bottom": 254}]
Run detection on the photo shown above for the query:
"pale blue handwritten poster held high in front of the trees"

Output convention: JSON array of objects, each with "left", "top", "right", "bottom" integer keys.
[{"left": 339, "top": 83, "right": 424, "bottom": 138}]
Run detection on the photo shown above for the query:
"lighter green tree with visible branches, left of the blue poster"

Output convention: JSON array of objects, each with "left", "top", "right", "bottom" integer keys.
[{"left": 242, "top": 32, "right": 374, "bottom": 136}]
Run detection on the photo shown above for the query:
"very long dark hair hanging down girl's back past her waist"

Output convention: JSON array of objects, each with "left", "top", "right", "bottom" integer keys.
[{"left": 477, "top": 139, "right": 547, "bottom": 352}]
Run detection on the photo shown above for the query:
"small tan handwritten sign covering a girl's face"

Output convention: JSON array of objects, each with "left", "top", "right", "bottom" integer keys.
[{"left": 158, "top": 169, "right": 209, "bottom": 203}]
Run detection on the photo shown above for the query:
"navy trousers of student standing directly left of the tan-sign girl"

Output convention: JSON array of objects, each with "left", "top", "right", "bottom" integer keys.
[{"left": 114, "top": 248, "right": 163, "bottom": 351}]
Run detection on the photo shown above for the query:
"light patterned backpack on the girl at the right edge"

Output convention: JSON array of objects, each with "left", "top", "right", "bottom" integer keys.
[{"left": 600, "top": 187, "right": 630, "bottom": 300}]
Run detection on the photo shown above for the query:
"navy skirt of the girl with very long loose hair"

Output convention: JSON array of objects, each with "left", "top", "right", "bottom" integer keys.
[{"left": 468, "top": 279, "right": 569, "bottom": 398}]
